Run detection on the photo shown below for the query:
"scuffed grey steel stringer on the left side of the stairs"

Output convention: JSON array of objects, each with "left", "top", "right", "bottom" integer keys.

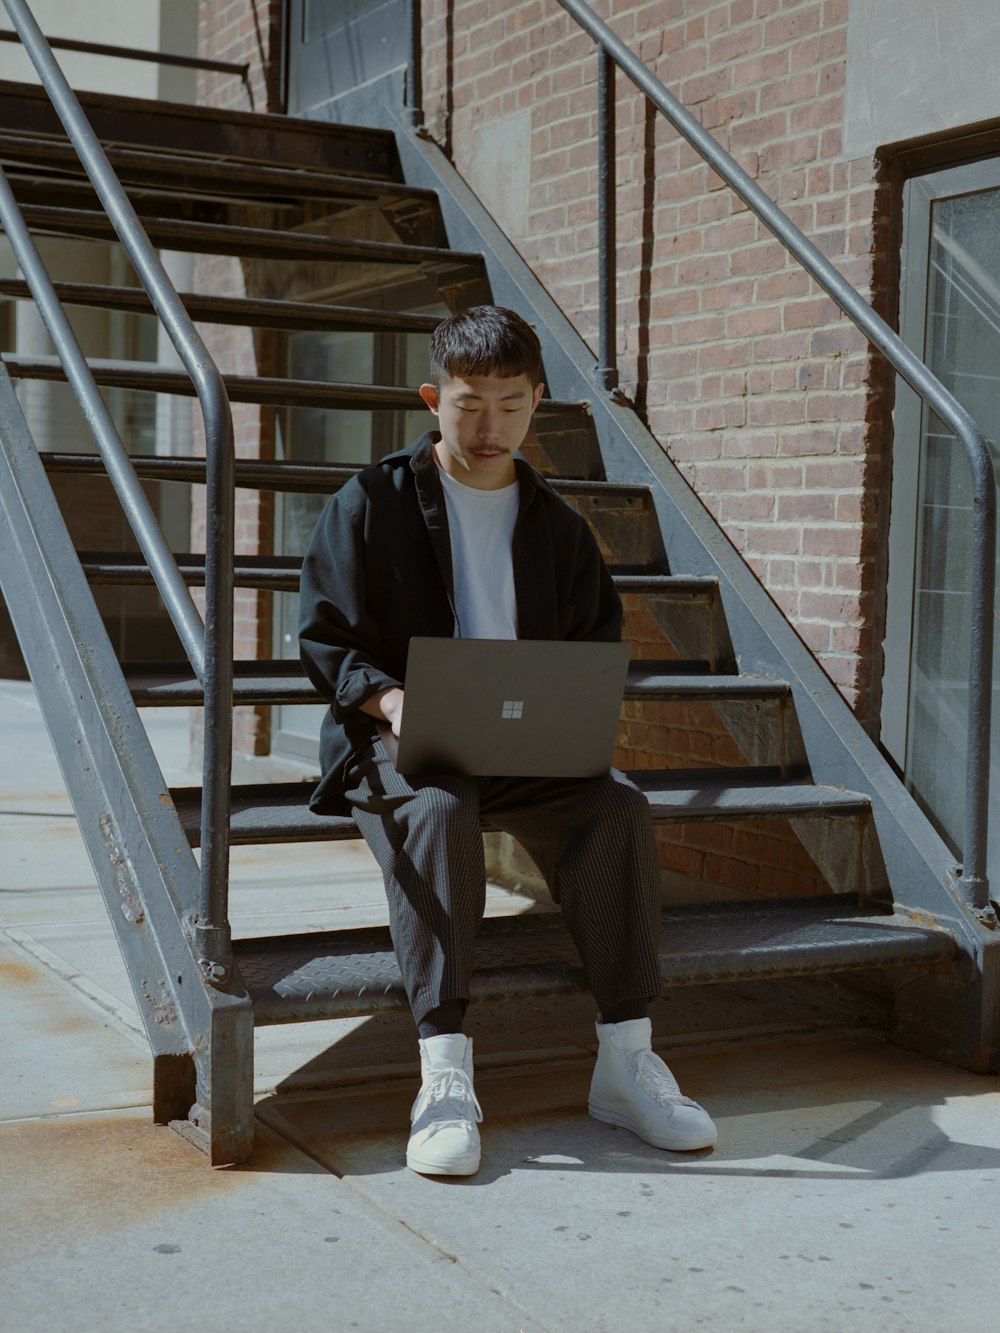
[{"left": 0, "top": 363, "right": 253, "bottom": 1164}]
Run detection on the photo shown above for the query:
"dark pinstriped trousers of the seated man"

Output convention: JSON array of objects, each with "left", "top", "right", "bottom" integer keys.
[{"left": 345, "top": 741, "right": 661, "bottom": 1022}]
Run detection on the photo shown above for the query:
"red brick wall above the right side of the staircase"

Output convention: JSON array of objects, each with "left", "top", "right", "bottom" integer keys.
[{"left": 424, "top": 0, "right": 885, "bottom": 722}]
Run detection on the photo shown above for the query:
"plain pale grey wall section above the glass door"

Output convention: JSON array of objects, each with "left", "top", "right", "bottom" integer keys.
[{"left": 844, "top": 0, "right": 1000, "bottom": 157}]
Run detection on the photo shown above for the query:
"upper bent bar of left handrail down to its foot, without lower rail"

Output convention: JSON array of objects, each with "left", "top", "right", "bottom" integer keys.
[{"left": 3, "top": 0, "right": 236, "bottom": 986}]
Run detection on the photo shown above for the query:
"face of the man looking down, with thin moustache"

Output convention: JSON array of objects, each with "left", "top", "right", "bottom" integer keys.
[{"left": 420, "top": 375, "right": 543, "bottom": 491}]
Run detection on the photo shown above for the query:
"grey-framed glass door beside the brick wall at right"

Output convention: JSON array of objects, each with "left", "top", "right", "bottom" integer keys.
[{"left": 883, "top": 163, "right": 1000, "bottom": 881}]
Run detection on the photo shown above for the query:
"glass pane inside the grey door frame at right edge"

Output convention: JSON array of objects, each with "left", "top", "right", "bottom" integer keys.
[{"left": 907, "top": 189, "right": 1000, "bottom": 880}]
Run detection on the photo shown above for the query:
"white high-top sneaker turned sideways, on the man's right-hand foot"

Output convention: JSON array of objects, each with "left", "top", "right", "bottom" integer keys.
[{"left": 589, "top": 1018, "right": 719, "bottom": 1152}]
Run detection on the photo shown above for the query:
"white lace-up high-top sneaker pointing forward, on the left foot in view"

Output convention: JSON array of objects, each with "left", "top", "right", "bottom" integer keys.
[{"left": 407, "top": 1032, "right": 483, "bottom": 1176}]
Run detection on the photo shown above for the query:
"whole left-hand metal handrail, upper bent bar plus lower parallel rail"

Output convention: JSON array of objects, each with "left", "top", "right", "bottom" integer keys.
[{"left": 3, "top": 0, "right": 235, "bottom": 985}]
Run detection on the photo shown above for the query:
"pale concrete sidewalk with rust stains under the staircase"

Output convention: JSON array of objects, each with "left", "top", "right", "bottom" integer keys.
[{"left": 0, "top": 681, "right": 1000, "bottom": 1333}]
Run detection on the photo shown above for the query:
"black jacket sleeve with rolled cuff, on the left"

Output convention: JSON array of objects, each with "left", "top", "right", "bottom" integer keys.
[{"left": 299, "top": 480, "right": 400, "bottom": 721}]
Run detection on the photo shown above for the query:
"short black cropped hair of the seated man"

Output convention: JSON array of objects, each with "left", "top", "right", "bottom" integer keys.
[{"left": 429, "top": 305, "right": 541, "bottom": 389}]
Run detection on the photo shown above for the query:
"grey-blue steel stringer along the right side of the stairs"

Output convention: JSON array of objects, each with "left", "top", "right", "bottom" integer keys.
[{"left": 386, "top": 119, "right": 1000, "bottom": 1002}]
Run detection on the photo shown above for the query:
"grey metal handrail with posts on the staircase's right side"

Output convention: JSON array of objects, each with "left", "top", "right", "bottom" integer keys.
[{"left": 407, "top": 0, "right": 996, "bottom": 912}]
